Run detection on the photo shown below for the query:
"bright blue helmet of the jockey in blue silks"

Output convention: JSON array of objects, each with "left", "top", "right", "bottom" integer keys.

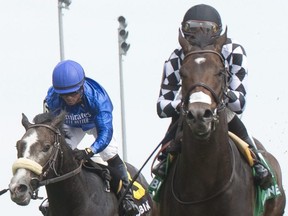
[{"left": 52, "top": 60, "right": 85, "bottom": 94}]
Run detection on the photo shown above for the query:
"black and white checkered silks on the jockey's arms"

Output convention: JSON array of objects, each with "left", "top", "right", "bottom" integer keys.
[{"left": 157, "top": 38, "right": 248, "bottom": 121}]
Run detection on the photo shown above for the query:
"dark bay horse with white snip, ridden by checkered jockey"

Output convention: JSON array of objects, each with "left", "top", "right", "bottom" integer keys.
[{"left": 159, "top": 29, "right": 285, "bottom": 216}]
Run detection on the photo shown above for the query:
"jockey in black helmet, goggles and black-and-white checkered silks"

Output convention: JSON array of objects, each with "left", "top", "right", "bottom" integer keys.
[{"left": 152, "top": 4, "right": 272, "bottom": 189}]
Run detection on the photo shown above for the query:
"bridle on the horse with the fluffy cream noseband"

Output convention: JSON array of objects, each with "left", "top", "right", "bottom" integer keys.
[{"left": 16, "top": 124, "right": 82, "bottom": 199}]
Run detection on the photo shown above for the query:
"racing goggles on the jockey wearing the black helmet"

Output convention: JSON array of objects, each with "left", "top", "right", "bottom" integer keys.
[{"left": 182, "top": 20, "right": 220, "bottom": 35}]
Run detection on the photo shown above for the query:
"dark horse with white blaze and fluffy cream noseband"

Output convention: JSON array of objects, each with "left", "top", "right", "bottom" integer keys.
[{"left": 9, "top": 113, "right": 152, "bottom": 216}]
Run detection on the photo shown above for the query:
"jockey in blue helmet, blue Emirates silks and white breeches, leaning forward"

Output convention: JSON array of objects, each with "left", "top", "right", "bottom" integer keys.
[{"left": 44, "top": 60, "right": 139, "bottom": 216}]
